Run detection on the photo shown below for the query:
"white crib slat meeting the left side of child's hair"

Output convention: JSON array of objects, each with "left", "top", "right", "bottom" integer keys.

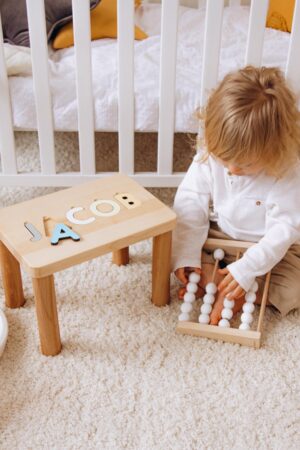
[{"left": 200, "top": 0, "right": 224, "bottom": 107}]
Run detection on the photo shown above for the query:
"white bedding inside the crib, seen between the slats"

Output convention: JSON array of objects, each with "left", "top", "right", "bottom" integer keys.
[{"left": 10, "top": 4, "right": 290, "bottom": 132}]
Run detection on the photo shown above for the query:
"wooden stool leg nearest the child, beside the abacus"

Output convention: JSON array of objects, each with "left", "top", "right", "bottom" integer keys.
[{"left": 152, "top": 231, "right": 172, "bottom": 306}]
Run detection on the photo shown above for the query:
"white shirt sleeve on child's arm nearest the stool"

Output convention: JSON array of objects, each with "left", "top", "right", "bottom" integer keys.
[{"left": 172, "top": 161, "right": 211, "bottom": 270}]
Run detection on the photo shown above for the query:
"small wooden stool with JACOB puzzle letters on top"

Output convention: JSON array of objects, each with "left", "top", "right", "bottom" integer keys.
[{"left": 0, "top": 175, "right": 176, "bottom": 355}]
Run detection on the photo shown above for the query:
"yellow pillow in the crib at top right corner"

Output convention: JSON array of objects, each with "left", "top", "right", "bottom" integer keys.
[{"left": 267, "top": 0, "right": 295, "bottom": 32}]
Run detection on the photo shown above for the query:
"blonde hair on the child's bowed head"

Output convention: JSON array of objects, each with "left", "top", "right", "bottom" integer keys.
[{"left": 198, "top": 66, "right": 300, "bottom": 177}]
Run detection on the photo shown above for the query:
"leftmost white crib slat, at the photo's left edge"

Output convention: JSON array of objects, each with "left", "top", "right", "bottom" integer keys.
[{"left": 0, "top": 15, "right": 17, "bottom": 174}]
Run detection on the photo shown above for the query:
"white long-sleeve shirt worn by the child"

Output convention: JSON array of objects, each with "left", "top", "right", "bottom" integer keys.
[{"left": 172, "top": 153, "right": 300, "bottom": 291}]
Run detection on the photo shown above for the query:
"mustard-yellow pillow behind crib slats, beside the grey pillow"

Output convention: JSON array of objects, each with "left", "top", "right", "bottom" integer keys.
[{"left": 53, "top": 0, "right": 148, "bottom": 49}]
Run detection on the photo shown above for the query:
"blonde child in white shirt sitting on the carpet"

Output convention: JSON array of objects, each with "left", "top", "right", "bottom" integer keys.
[{"left": 172, "top": 66, "right": 300, "bottom": 325}]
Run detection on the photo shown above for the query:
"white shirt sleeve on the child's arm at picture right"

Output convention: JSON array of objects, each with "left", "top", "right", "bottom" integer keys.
[{"left": 227, "top": 171, "right": 300, "bottom": 291}]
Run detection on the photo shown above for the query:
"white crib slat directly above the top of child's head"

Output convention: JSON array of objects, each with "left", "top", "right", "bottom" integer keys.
[{"left": 245, "top": 0, "right": 269, "bottom": 66}]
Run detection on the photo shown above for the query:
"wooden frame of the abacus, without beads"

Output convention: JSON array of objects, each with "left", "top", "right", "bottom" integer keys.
[{"left": 176, "top": 238, "right": 271, "bottom": 348}]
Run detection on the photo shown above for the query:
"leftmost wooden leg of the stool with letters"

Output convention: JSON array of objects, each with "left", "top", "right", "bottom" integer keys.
[{"left": 0, "top": 241, "right": 25, "bottom": 308}]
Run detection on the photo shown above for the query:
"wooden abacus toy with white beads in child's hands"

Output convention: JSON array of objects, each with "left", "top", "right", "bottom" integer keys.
[{"left": 176, "top": 239, "right": 271, "bottom": 348}]
